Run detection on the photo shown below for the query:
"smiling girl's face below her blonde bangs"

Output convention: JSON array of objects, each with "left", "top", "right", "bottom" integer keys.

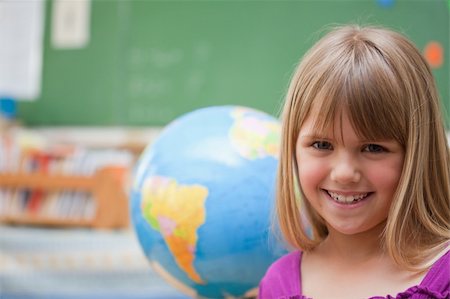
[{"left": 296, "top": 112, "right": 404, "bottom": 235}]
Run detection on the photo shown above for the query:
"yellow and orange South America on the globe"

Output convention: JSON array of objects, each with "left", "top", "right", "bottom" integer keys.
[{"left": 141, "top": 176, "right": 208, "bottom": 284}]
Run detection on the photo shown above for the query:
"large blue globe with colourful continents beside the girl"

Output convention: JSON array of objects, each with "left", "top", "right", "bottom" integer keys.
[{"left": 131, "top": 106, "right": 282, "bottom": 298}]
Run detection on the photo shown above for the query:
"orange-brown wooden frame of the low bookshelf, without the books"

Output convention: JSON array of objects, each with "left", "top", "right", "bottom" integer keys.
[{"left": 0, "top": 167, "right": 129, "bottom": 228}]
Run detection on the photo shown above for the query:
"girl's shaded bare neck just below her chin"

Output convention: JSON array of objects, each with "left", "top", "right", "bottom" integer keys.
[{"left": 317, "top": 223, "right": 386, "bottom": 263}]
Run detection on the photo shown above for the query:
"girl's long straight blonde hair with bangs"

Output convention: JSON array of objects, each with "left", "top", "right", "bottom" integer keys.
[{"left": 277, "top": 26, "right": 450, "bottom": 270}]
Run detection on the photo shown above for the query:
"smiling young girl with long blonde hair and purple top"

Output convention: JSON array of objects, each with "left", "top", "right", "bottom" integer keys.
[{"left": 259, "top": 26, "right": 450, "bottom": 299}]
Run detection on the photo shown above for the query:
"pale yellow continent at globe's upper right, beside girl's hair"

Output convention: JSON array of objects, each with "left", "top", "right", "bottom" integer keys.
[{"left": 229, "top": 108, "right": 281, "bottom": 160}]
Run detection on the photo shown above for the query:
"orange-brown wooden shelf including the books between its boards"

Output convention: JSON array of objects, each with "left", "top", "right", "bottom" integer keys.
[{"left": 0, "top": 167, "right": 129, "bottom": 229}]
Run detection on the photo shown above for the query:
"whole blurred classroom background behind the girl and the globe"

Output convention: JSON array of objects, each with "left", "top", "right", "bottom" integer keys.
[{"left": 0, "top": 0, "right": 450, "bottom": 299}]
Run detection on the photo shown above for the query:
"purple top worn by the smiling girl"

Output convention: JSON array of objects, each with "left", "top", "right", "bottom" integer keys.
[{"left": 258, "top": 251, "right": 450, "bottom": 299}]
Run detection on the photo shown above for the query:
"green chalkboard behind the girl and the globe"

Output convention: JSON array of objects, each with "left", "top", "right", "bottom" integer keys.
[{"left": 19, "top": 0, "right": 450, "bottom": 126}]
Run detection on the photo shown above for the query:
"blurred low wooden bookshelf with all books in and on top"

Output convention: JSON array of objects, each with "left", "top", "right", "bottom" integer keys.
[{"left": 0, "top": 127, "right": 137, "bottom": 229}]
